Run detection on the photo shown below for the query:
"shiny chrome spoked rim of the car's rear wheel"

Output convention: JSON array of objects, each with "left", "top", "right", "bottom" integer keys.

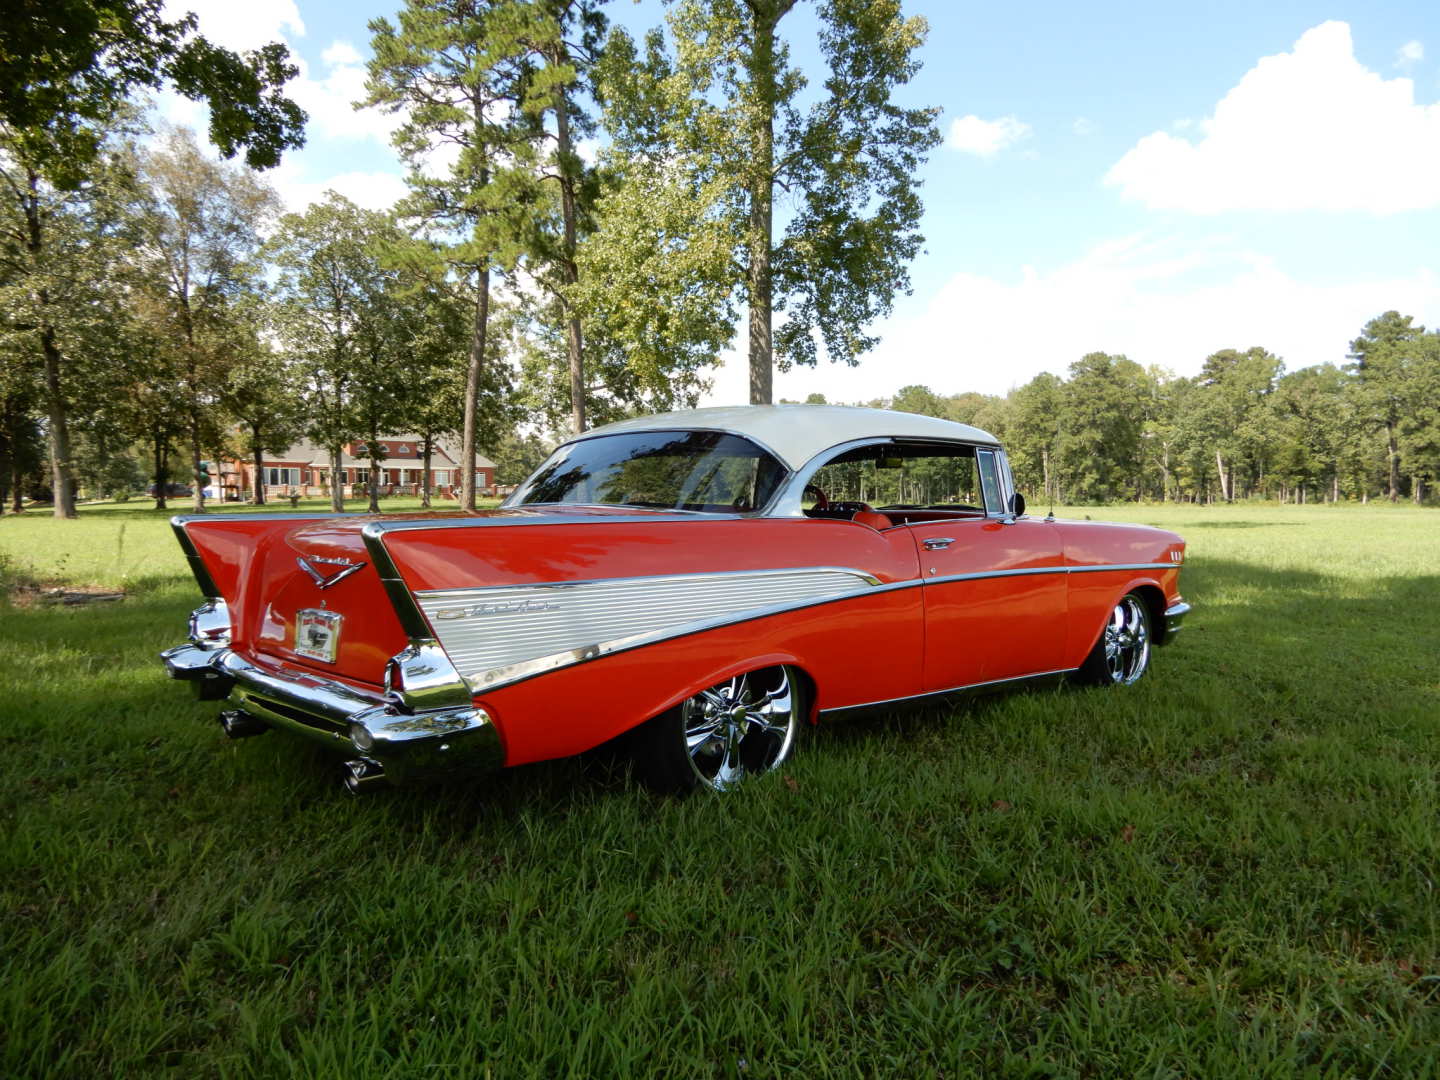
[{"left": 680, "top": 668, "right": 801, "bottom": 791}]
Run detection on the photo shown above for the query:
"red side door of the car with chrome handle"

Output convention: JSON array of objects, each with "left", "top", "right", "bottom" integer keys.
[{"left": 906, "top": 449, "right": 1066, "bottom": 693}]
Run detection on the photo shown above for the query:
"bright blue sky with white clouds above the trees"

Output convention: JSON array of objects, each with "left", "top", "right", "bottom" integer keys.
[{"left": 158, "top": 0, "right": 1440, "bottom": 405}]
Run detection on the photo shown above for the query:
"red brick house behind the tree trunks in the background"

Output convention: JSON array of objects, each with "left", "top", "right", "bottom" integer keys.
[{"left": 219, "top": 435, "right": 495, "bottom": 501}]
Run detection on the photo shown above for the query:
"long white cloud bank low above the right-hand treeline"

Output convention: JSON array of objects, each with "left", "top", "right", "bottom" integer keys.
[{"left": 704, "top": 238, "right": 1440, "bottom": 405}]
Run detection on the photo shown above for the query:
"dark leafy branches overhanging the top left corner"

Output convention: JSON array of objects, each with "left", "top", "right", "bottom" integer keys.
[{"left": 0, "top": 0, "right": 305, "bottom": 177}]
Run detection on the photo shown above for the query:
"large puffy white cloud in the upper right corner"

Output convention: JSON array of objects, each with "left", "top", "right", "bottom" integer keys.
[{"left": 1104, "top": 22, "right": 1440, "bottom": 213}]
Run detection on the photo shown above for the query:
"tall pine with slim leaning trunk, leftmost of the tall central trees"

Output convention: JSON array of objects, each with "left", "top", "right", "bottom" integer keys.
[{"left": 366, "top": 0, "right": 534, "bottom": 511}]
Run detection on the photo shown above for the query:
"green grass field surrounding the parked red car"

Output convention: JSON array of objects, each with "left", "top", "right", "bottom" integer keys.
[{"left": 0, "top": 504, "right": 1440, "bottom": 1077}]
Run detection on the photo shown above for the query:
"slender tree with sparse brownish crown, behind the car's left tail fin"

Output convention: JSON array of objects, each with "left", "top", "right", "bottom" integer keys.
[{"left": 134, "top": 130, "right": 279, "bottom": 513}]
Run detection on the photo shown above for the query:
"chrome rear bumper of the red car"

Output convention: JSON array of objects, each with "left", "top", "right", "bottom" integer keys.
[{"left": 160, "top": 644, "right": 504, "bottom": 783}]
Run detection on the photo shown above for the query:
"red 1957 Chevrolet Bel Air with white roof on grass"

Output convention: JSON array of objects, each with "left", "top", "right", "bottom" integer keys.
[{"left": 161, "top": 405, "right": 1189, "bottom": 791}]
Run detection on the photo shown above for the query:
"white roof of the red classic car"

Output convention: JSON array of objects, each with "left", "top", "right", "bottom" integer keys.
[{"left": 570, "top": 405, "right": 999, "bottom": 469}]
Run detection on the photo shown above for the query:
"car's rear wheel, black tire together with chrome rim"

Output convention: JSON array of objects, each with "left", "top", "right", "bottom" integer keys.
[{"left": 631, "top": 667, "right": 805, "bottom": 795}]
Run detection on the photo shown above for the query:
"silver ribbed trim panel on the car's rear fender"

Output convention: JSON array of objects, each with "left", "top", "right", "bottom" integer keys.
[{"left": 416, "top": 567, "right": 880, "bottom": 687}]
